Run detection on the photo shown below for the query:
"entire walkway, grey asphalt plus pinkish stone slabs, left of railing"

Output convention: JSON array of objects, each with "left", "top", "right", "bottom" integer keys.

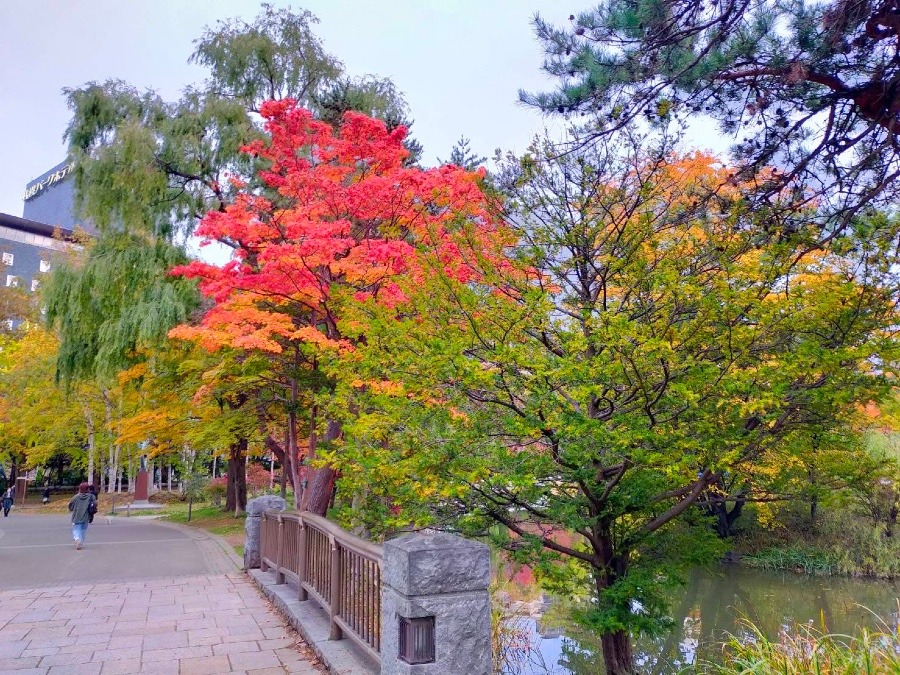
[{"left": 0, "top": 516, "right": 324, "bottom": 675}]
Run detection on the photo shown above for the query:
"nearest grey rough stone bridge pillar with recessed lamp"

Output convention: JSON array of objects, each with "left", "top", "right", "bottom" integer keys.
[{"left": 381, "top": 533, "right": 492, "bottom": 675}]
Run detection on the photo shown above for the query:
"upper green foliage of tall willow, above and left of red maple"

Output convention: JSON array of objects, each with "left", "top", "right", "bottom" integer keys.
[{"left": 64, "top": 4, "right": 422, "bottom": 238}]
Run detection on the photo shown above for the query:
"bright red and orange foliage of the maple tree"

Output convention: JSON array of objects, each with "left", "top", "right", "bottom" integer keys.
[{"left": 170, "top": 100, "right": 510, "bottom": 353}]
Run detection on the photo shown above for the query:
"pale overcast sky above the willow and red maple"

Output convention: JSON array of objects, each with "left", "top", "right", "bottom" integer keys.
[{"left": 0, "top": 0, "right": 572, "bottom": 216}]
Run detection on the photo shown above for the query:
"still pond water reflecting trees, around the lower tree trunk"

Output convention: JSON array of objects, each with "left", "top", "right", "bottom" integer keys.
[{"left": 508, "top": 565, "right": 900, "bottom": 675}]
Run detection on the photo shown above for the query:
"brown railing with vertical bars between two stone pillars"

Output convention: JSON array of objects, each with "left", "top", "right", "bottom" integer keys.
[{"left": 260, "top": 511, "right": 384, "bottom": 663}]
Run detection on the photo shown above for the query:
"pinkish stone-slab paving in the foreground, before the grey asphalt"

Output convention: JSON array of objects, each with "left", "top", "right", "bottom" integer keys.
[{"left": 0, "top": 573, "right": 326, "bottom": 675}]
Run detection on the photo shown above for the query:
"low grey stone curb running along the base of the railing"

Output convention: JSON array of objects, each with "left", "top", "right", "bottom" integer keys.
[{"left": 247, "top": 569, "right": 381, "bottom": 675}]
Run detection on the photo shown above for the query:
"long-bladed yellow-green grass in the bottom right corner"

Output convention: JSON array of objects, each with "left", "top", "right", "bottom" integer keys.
[{"left": 696, "top": 623, "right": 900, "bottom": 675}]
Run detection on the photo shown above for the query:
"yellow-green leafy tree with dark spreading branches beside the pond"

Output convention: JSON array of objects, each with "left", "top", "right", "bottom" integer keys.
[{"left": 343, "top": 135, "right": 897, "bottom": 675}]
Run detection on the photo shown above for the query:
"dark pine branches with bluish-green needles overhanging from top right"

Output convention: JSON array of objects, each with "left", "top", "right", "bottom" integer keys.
[{"left": 521, "top": 0, "right": 900, "bottom": 229}]
